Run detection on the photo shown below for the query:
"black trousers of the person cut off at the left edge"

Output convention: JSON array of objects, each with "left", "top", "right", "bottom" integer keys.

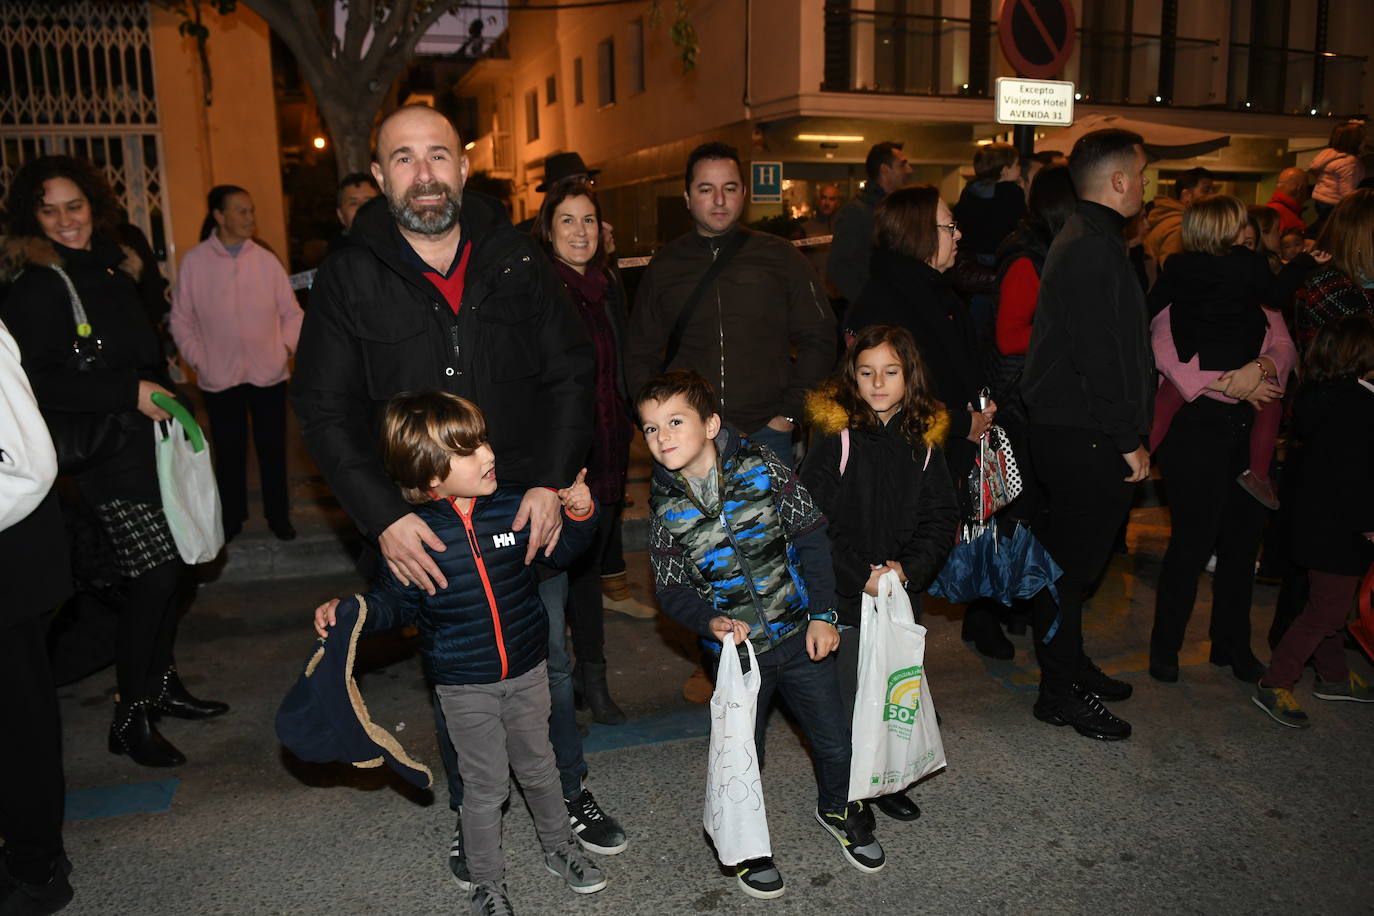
[{"left": 0, "top": 617, "right": 65, "bottom": 884}]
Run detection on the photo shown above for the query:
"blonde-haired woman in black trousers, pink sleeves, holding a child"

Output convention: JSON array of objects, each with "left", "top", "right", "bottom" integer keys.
[{"left": 1150, "top": 195, "right": 1312, "bottom": 683}]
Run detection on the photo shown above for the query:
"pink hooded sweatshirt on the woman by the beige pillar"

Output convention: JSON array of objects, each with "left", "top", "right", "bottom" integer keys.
[{"left": 172, "top": 232, "right": 304, "bottom": 391}]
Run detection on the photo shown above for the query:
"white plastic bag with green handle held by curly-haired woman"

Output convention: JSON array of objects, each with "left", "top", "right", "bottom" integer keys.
[{"left": 153, "top": 417, "right": 224, "bottom": 563}]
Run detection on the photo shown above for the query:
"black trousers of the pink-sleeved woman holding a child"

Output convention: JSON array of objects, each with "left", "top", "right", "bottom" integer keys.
[{"left": 1150, "top": 397, "right": 1267, "bottom": 665}]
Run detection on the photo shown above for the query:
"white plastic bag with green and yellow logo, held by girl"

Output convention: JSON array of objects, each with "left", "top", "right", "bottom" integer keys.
[{"left": 849, "top": 573, "right": 945, "bottom": 802}]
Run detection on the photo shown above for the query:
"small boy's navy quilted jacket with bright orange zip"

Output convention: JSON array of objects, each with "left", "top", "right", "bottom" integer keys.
[{"left": 363, "top": 486, "right": 596, "bottom": 684}]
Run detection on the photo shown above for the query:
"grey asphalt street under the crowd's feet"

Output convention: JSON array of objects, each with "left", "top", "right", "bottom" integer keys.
[{"left": 45, "top": 497, "right": 1374, "bottom": 915}]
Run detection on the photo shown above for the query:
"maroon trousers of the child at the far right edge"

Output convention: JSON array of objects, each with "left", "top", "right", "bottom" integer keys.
[{"left": 1260, "top": 570, "right": 1360, "bottom": 691}]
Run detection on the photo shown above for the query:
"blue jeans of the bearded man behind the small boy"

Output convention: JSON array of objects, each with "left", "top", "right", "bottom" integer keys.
[{"left": 430, "top": 573, "right": 582, "bottom": 812}]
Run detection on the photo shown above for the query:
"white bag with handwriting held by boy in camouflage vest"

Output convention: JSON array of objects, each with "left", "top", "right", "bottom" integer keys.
[{"left": 702, "top": 636, "right": 772, "bottom": 865}]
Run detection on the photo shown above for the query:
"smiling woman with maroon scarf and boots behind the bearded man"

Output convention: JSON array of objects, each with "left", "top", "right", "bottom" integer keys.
[{"left": 534, "top": 181, "right": 633, "bottom": 725}]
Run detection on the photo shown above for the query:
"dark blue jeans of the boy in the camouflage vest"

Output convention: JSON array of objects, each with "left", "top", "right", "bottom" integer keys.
[{"left": 741, "top": 632, "right": 851, "bottom": 812}]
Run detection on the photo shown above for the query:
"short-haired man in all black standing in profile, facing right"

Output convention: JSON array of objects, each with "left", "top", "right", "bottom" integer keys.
[{"left": 1022, "top": 129, "right": 1154, "bottom": 740}]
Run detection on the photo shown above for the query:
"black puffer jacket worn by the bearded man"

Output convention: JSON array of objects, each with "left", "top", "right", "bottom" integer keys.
[{"left": 291, "top": 192, "right": 595, "bottom": 537}]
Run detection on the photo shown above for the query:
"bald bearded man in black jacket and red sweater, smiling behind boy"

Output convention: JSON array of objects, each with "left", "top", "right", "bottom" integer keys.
[{"left": 291, "top": 106, "right": 625, "bottom": 884}]
